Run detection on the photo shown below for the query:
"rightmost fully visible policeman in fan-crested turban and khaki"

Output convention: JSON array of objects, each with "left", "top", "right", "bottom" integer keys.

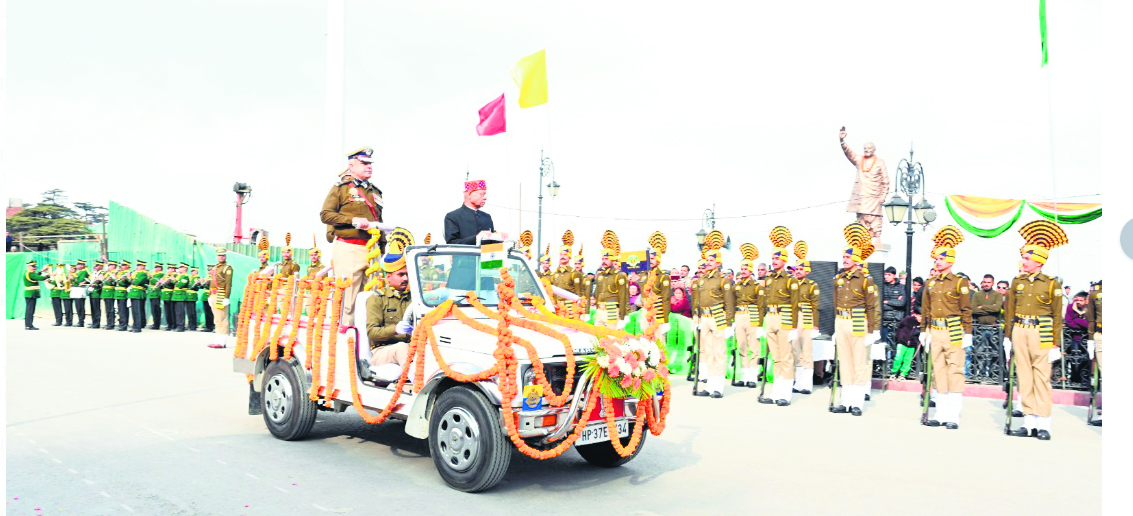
[{"left": 1004, "top": 220, "right": 1068, "bottom": 441}]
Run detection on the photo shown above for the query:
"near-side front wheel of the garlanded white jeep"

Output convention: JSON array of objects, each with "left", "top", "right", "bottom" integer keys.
[{"left": 428, "top": 387, "right": 511, "bottom": 492}]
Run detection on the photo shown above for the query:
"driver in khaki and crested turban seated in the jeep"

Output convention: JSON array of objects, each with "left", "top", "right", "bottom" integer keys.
[{"left": 366, "top": 230, "right": 414, "bottom": 365}]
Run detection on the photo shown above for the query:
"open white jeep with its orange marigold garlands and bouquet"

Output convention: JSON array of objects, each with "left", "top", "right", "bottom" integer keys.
[{"left": 233, "top": 245, "right": 670, "bottom": 491}]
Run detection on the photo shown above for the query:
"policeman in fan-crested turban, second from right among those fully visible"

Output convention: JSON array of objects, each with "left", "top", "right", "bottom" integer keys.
[{"left": 920, "top": 226, "right": 972, "bottom": 430}]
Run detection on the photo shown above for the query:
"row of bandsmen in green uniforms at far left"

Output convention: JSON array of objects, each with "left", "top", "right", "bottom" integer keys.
[{"left": 24, "top": 260, "right": 231, "bottom": 332}]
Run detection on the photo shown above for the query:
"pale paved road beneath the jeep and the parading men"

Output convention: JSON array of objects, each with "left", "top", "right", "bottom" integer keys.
[{"left": 6, "top": 320, "right": 1101, "bottom": 516}]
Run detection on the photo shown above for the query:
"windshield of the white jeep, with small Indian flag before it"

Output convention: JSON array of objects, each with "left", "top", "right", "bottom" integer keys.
[{"left": 416, "top": 249, "right": 543, "bottom": 306}]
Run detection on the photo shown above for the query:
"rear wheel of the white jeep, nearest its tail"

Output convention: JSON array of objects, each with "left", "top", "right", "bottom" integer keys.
[{"left": 259, "top": 359, "right": 317, "bottom": 441}]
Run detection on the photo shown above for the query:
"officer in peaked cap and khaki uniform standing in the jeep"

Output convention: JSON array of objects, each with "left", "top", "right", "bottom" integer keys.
[{"left": 320, "top": 147, "right": 392, "bottom": 331}]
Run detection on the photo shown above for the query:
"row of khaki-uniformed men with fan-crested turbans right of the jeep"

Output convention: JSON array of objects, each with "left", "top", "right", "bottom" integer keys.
[{"left": 530, "top": 220, "right": 1087, "bottom": 440}]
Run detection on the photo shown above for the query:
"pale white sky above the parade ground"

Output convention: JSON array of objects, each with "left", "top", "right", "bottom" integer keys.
[{"left": 0, "top": 0, "right": 1102, "bottom": 290}]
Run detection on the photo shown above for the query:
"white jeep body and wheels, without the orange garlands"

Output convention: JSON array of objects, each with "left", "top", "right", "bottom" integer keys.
[{"left": 233, "top": 245, "right": 657, "bottom": 492}]
